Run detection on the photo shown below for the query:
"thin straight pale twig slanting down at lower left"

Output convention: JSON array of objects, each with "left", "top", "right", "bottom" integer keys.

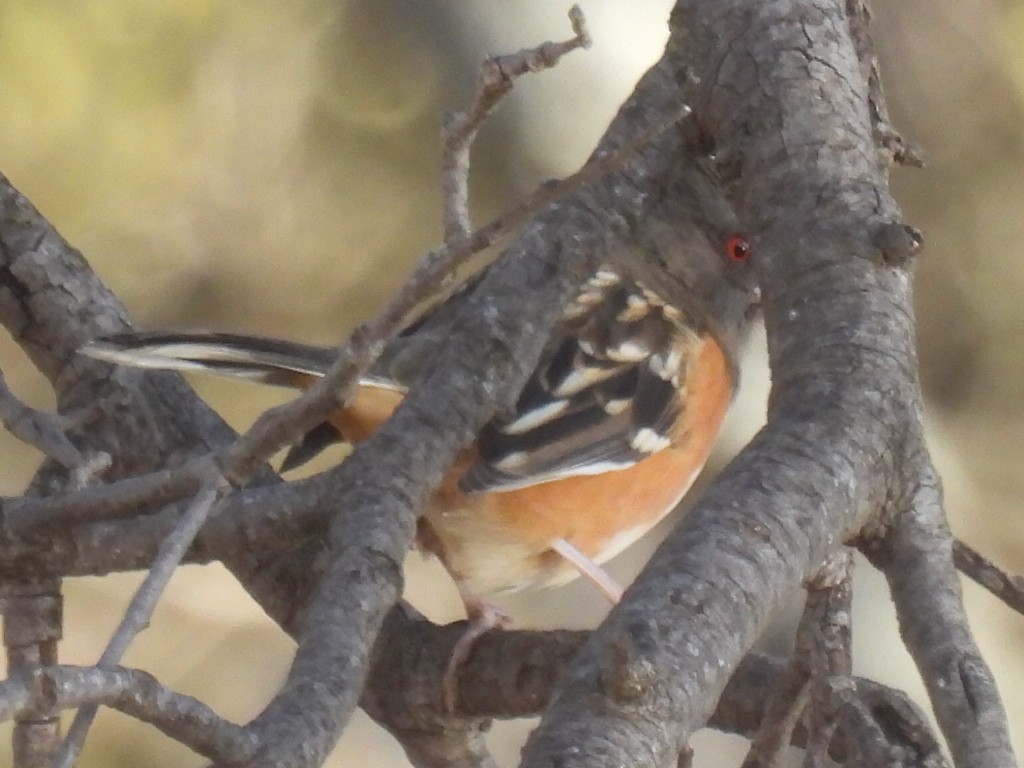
[{"left": 53, "top": 477, "right": 230, "bottom": 768}]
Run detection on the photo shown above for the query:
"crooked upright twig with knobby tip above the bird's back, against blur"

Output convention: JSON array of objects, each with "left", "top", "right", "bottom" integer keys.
[{"left": 441, "top": 5, "right": 591, "bottom": 246}]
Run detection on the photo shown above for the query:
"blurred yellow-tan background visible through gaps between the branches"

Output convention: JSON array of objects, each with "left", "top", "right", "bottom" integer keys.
[{"left": 0, "top": 0, "right": 1024, "bottom": 768}]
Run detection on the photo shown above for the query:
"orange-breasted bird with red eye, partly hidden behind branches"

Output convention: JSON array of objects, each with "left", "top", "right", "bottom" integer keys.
[{"left": 81, "top": 165, "right": 760, "bottom": 708}]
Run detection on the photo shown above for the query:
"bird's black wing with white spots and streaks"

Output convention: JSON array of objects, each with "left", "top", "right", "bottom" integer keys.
[{"left": 461, "top": 270, "right": 699, "bottom": 492}]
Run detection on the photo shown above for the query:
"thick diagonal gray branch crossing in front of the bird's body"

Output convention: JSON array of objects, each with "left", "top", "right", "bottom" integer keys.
[{"left": 234, "top": 48, "right": 737, "bottom": 763}]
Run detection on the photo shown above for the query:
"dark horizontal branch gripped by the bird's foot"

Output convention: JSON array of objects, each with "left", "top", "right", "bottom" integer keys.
[{"left": 360, "top": 605, "right": 943, "bottom": 768}]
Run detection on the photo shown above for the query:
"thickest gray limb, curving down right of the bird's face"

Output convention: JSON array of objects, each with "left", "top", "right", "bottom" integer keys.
[{"left": 523, "top": 0, "right": 983, "bottom": 767}]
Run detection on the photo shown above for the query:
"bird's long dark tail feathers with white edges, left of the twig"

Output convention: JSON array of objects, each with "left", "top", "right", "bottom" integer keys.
[{"left": 81, "top": 332, "right": 335, "bottom": 387}]
